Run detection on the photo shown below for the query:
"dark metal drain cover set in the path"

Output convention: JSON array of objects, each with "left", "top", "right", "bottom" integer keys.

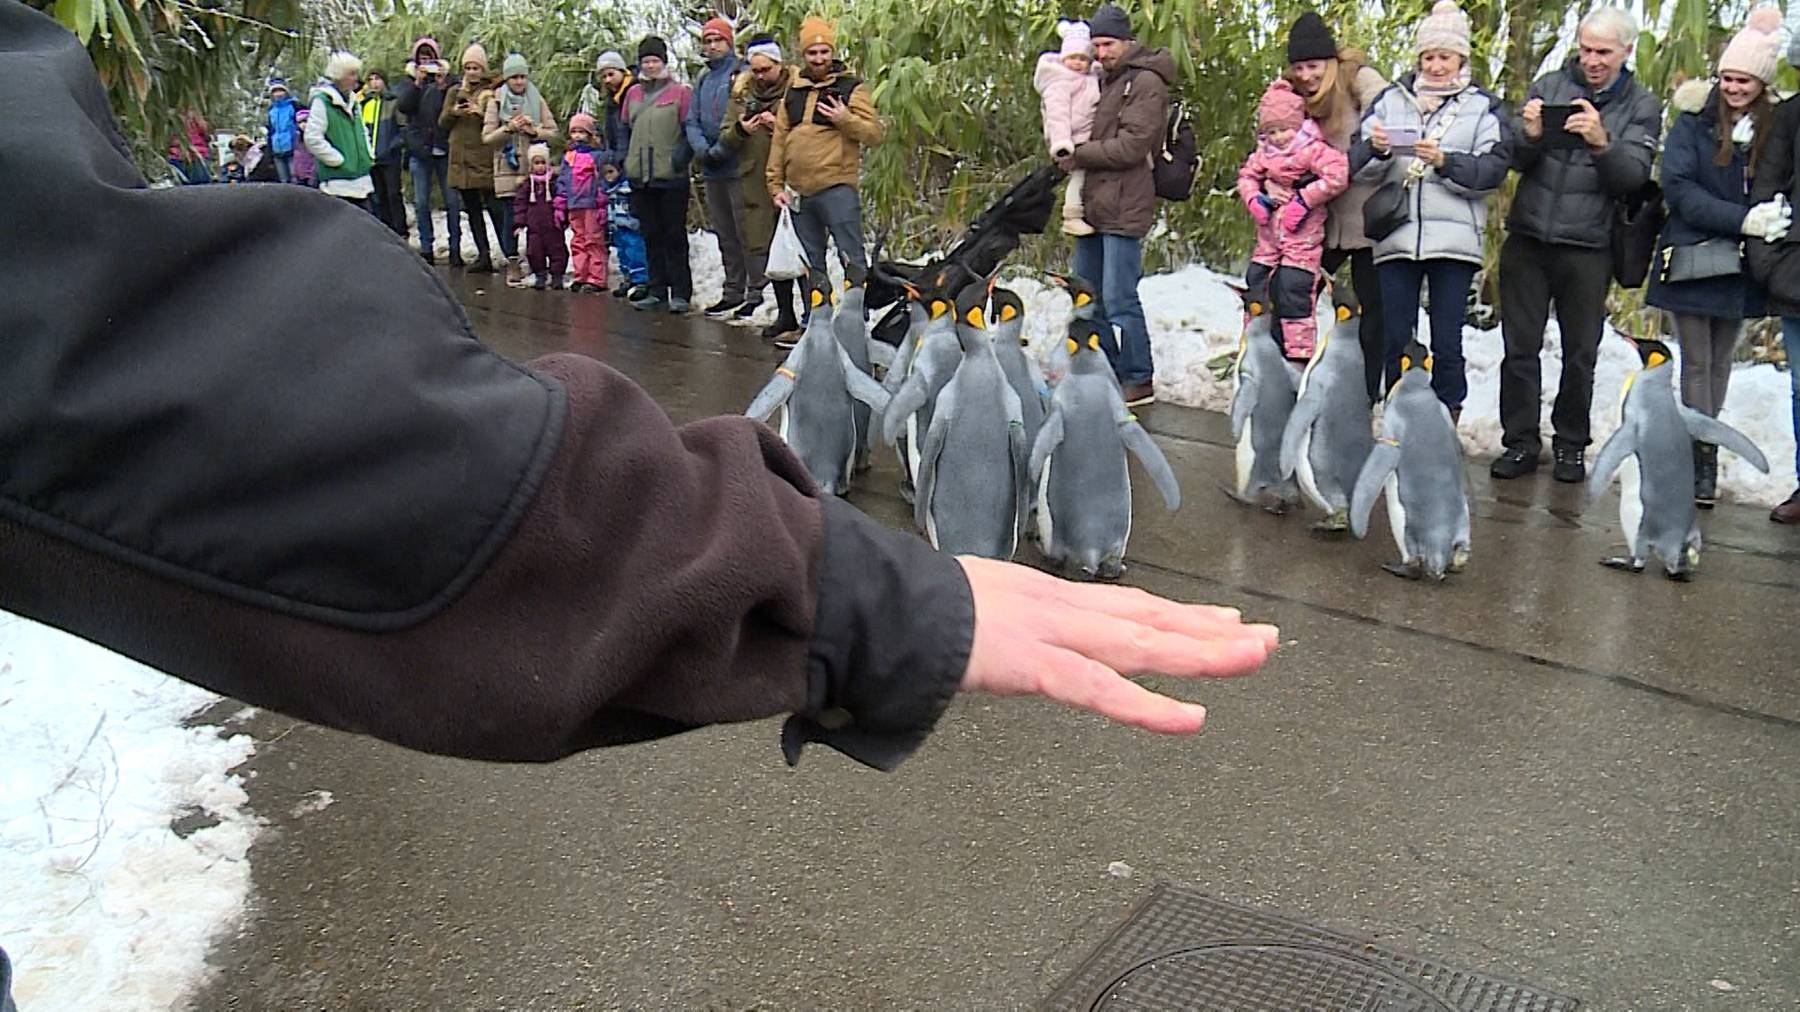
[{"left": 1044, "top": 882, "right": 1580, "bottom": 1012}]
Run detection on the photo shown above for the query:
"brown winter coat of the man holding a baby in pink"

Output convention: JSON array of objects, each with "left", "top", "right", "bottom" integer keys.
[{"left": 1075, "top": 45, "right": 1175, "bottom": 239}]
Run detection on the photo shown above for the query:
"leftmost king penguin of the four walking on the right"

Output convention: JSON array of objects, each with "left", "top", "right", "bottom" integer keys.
[{"left": 1228, "top": 301, "right": 1300, "bottom": 513}]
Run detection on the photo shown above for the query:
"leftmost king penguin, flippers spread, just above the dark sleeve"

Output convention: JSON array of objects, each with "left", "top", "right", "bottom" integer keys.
[{"left": 743, "top": 277, "right": 887, "bottom": 495}]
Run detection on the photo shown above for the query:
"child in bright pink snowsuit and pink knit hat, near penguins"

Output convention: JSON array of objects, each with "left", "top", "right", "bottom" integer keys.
[{"left": 1238, "top": 79, "right": 1350, "bottom": 362}]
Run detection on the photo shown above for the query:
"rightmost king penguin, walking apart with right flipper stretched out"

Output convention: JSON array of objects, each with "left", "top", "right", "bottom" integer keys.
[{"left": 1588, "top": 340, "right": 1769, "bottom": 580}]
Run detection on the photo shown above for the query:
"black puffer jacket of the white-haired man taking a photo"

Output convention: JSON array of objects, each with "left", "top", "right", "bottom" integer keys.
[{"left": 1507, "top": 59, "right": 1663, "bottom": 248}]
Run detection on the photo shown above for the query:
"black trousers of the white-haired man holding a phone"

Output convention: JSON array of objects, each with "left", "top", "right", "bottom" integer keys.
[{"left": 1499, "top": 234, "right": 1613, "bottom": 454}]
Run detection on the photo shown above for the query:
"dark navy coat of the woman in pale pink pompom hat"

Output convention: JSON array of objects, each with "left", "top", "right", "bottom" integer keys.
[{"left": 1645, "top": 90, "right": 1762, "bottom": 319}]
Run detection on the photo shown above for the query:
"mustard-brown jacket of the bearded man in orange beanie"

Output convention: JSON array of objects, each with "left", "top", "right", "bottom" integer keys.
[{"left": 767, "top": 63, "right": 882, "bottom": 196}]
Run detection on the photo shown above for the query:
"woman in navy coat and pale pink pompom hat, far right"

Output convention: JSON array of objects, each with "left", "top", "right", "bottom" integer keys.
[{"left": 1647, "top": 7, "right": 1789, "bottom": 510}]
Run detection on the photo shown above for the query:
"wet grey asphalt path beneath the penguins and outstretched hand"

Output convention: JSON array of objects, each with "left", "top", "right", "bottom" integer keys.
[{"left": 196, "top": 277, "right": 1800, "bottom": 1010}]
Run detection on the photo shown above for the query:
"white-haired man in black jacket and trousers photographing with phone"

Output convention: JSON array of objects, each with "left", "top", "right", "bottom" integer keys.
[{"left": 1490, "top": 7, "right": 1663, "bottom": 483}]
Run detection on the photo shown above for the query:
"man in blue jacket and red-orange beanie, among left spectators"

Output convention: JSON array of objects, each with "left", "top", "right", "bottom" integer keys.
[{"left": 684, "top": 16, "right": 765, "bottom": 317}]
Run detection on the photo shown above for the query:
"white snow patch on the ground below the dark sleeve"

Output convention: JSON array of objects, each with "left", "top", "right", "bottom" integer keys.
[{"left": 0, "top": 612, "right": 261, "bottom": 1012}]
